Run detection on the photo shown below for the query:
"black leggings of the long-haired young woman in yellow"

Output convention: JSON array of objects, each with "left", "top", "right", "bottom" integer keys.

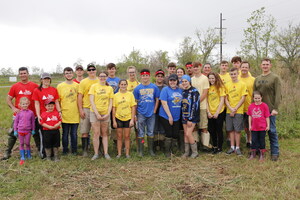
[{"left": 208, "top": 111, "right": 225, "bottom": 149}]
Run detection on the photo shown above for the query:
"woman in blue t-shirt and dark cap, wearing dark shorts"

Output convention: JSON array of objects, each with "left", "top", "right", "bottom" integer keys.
[{"left": 159, "top": 74, "right": 182, "bottom": 157}]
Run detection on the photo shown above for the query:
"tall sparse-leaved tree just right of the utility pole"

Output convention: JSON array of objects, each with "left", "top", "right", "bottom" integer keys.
[{"left": 238, "top": 7, "right": 276, "bottom": 66}]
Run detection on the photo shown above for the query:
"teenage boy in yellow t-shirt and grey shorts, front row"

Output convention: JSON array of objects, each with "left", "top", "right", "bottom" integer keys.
[{"left": 225, "top": 67, "right": 248, "bottom": 156}]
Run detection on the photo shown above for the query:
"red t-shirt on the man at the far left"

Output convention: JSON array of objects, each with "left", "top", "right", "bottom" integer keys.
[{"left": 8, "top": 81, "right": 38, "bottom": 115}]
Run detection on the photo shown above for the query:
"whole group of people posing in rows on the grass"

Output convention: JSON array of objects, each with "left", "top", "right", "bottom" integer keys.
[{"left": 2, "top": 56, "right": 281, "bottom": 164}]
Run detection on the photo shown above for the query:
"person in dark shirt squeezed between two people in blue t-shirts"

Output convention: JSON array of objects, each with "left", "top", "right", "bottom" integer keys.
[{"left": 154, "top": 69, "right": 166, "bottom": 150}]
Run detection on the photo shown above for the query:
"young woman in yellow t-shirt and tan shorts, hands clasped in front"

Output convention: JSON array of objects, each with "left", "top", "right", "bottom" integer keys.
[{"left": 89, "top": 72, "right": 114, "bottom": 160}]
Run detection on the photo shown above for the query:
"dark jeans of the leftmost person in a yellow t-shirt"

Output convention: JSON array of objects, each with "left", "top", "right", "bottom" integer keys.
[{"left": 62, "top": 123, "right": 79, "bottom": 153}]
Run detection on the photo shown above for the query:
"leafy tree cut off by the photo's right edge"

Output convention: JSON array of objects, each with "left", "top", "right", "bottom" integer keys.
[{"left": 274, "top": 23, "right": 300, "bottom": 77}]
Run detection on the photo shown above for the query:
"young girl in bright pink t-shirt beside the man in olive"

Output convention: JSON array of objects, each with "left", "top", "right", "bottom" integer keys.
[{"left": 247, "top": 91, "right": 270, "bottom": 161}]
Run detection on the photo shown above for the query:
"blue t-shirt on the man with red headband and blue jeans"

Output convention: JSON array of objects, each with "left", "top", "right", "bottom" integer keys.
[{"left": 133, "top": 83, "right": 160, "bottom": 117}]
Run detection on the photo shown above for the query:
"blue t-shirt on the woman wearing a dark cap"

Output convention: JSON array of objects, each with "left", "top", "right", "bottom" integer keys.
[{"left": 159, "top": 86, "right": 182, "bottom": 121}]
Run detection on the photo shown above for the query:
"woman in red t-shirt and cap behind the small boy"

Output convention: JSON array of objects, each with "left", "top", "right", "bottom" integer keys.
[{"left": 32, "top": 73, "right": 61, "bottom": 157}]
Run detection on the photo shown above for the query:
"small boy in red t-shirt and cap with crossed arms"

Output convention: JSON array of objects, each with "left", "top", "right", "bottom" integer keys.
[{"left": 41, "top": 100, "right": 61, "bottom": 162}]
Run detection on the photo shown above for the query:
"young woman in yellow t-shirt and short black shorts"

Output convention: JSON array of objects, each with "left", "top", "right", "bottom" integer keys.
[{"left": 112, "top": 79, "right": 136, "bottom": 158}]
